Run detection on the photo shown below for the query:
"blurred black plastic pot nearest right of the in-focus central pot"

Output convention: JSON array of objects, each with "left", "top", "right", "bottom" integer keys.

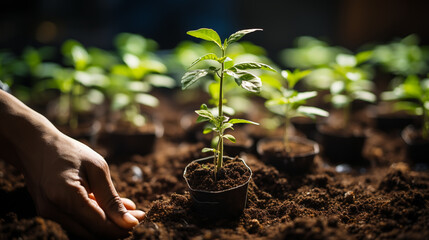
[{"left": 257, "top": 137, "right": 319, "bottom": 174}]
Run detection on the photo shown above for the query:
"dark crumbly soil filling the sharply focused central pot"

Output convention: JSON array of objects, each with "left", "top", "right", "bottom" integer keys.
[{"left": 185, "top": 158, "right": 251, "bottom": 191}]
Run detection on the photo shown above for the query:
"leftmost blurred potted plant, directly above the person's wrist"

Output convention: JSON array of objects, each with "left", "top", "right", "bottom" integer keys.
[{"left": 38, "top": 40, "right": 108, "bottom": 140}]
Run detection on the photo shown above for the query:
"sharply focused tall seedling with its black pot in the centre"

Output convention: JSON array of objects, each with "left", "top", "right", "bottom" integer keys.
[{"left": 182, "top": 28, "right": 274, "bottom": 218}]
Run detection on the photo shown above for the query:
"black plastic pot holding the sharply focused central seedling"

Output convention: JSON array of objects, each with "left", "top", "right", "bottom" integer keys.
[{"left": 183, "top": 156, "right": 252, "bottom": 219}]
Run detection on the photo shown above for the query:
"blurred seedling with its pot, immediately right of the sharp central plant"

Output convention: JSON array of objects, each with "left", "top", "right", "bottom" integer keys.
[{"left": 257, "top": 69, "right": 329, "bottom": 173}]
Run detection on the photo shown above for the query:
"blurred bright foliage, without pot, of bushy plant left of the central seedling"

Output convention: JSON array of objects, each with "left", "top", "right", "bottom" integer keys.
[{"left": 104, "top": 33, "right": 175, "bottom": 127}]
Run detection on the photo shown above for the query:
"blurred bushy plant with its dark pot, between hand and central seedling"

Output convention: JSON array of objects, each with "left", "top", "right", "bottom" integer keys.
[{"left": 100, "top": 34, "right": 174, "bottom": 155}]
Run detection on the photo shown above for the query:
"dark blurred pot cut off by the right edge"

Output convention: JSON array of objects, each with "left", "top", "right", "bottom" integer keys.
[{"left": 401, "top": 125, "right": 429, "bottom": 164}]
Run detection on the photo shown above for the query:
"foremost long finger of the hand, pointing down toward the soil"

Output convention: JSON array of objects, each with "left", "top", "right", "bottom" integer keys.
[{"left": 87, "top": 159, "right": 139, "bottom": 229}]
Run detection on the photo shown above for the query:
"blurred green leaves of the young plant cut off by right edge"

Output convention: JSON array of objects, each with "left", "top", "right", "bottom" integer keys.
[{"left": 381, "top": 75, "right": 429, "bottom": 140}]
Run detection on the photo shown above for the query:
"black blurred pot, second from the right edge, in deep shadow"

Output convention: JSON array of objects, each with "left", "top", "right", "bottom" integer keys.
[{"left": 317, "top": 125, "right": 368, "bottom": 166}]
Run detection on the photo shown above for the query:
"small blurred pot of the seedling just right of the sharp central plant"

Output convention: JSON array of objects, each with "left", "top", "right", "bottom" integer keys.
[{"left": 257, "top": 137, "right": 319, "bottom": 174}]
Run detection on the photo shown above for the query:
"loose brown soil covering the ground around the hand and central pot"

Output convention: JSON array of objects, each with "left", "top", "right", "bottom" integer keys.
[{"left": 0, "top": 91, "right": 429, "bottom": 240}]
